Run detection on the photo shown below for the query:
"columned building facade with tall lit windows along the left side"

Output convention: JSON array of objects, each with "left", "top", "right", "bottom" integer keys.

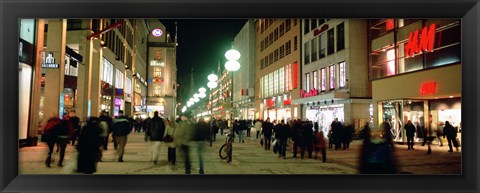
[{"left": 19, "top": 19, "right": 147, "bottom": 145}]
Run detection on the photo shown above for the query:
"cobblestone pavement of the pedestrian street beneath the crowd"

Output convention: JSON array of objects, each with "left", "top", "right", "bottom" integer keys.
[{"left": 19, "top": 133, "right": 461, "bottom": 174}]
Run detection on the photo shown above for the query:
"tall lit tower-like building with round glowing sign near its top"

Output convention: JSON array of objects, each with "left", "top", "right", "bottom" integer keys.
[{"left": 146, "top": 19, "right": 177, "bottom": 117}]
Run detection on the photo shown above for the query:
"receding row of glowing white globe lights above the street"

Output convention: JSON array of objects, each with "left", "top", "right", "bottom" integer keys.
[{"left": 182, "top": 49, "right": 240, "bottom": 113}]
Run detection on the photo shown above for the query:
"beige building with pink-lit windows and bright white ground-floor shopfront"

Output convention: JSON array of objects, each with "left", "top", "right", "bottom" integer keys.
[{"left": 293, "top": 19, "right": 373, "bottom": 133}]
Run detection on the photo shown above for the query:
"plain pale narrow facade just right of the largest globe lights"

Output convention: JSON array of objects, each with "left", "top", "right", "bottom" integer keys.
[{"left": 233, "top": 19, "right": 255, "bottom": 120}]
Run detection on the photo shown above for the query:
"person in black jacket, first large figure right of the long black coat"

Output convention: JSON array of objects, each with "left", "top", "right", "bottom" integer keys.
[{"left": 112, "top": 110, "right": 132, "bottom": 162}]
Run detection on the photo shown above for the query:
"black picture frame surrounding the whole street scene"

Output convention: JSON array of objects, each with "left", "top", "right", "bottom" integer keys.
[{"left": 0, "top": 0, "right": 480, "bottom": 192}]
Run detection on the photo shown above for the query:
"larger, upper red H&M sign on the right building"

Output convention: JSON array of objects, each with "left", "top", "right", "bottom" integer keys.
[{"left": 405, "top": 24, "right": 436, "bottom": 57}]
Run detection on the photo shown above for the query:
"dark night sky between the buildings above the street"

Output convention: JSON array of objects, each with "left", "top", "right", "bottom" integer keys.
[{"left": 160, "top": 19, "right": 247, "bottom": 106}]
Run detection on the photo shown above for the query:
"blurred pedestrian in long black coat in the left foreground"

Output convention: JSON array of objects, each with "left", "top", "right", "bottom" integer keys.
[{"left": 77, "top": 117, "right": 101, "bottom": 174}]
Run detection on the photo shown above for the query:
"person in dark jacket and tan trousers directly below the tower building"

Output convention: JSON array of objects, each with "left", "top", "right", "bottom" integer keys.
[{"left": 148, "top": 111, "right": 165, "bottom": 165}]
